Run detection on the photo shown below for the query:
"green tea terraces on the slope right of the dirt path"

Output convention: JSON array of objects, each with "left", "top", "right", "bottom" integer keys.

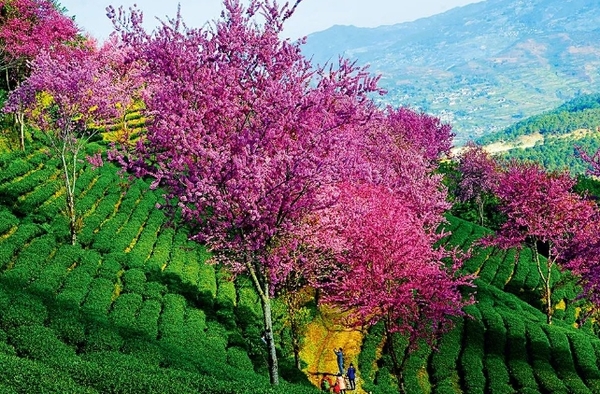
[{"left": 352, "top": 217, "right": 600, "bottom": 394}]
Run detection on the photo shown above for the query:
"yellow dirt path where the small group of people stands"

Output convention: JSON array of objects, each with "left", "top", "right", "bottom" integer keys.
[{"left": 300, "top": 308, "right": 365, "bottom": 394}]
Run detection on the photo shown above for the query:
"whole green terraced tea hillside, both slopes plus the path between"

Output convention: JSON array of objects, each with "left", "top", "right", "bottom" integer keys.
[{"left": 0, "top": 140, "right": 600, "bottom": 394}]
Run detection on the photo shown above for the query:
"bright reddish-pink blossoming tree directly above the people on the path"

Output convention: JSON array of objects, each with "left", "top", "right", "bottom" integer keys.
[{"left": 322, "top": 184, "right": 473, "bottom": 392}]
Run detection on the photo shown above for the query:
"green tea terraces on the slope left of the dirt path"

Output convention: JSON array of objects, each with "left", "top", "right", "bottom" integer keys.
[{"left": 0, "top": 145, "right": 314, "bottom": 393}]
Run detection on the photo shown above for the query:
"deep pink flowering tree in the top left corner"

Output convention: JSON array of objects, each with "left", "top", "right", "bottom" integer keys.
[{"left": 0, "top": 0, "right": 79, "bottom": 149}]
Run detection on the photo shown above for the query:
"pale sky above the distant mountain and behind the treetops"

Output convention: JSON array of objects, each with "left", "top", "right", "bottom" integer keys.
[{"left": 60, "top": 0, "right": 481, "bottom": 41}]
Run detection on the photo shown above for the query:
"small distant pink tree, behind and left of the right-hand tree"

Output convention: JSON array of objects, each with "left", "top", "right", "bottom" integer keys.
[{"left": 457, "top": 142, "right": 500, "bottom": 226}]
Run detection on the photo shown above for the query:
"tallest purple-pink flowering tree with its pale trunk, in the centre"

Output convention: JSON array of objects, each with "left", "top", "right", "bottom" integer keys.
[{"left": 109, "top": 0, "right": 377, "bottom": 385}]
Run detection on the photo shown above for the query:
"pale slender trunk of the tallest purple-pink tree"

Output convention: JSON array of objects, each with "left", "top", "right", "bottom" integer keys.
[{"left": 246, "top": 261, "right": 279, "bottom": 386}]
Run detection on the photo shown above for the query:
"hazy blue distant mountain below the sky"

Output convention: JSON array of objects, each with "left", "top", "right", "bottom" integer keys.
[{"left": 304, "top": 0, "right": 600, "bottom": 143}]
